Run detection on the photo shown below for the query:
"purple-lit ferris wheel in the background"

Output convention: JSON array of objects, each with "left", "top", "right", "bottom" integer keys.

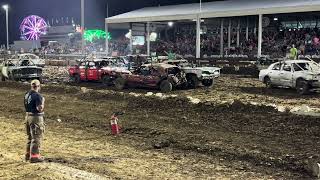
[{"left": 20, "top": 15, "right": 47, "bottom": 41}]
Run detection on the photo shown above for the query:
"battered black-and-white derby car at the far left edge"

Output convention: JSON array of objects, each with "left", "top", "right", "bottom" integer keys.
[{"left": 0, "top": 59, "right": 42, "bottom": 81}]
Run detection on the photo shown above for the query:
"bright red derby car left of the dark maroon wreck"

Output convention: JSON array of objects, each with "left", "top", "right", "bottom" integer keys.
[{"left": 69, "top": 60, "right": 128, "bottom": 85}]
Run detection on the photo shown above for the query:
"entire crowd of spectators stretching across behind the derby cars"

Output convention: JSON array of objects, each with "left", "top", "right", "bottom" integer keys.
[{"left": 1, "top": 25, "right": 320, "bottom": 57}]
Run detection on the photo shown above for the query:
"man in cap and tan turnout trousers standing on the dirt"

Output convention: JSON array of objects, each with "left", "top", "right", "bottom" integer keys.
[{"left": 24, "top": 80, "right": 45, "bottom": 163}]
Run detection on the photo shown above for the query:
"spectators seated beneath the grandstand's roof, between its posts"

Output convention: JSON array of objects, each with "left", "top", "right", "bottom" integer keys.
[{"left": 135, "top": 28, "right": 320, "bottom": 57}]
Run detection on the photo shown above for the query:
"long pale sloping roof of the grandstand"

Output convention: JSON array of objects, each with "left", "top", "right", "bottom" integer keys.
[{"left": 106, "top": 0, "right": 320, "bottom": 23}]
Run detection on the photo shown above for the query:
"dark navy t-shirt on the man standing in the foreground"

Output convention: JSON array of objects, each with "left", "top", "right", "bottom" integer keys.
[{"left": 24, "top": 90, "right": 43, "bottom": 114}]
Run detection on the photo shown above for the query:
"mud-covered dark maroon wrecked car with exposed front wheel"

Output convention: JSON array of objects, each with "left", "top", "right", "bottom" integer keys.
[{"left": 114, "top": 63, "right": 187, "bottom": 93}]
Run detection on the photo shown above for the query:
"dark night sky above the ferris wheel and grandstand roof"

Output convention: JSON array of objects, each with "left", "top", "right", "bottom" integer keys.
[{"left": 0, "top": 0, "right": 218, "bottom": 45}]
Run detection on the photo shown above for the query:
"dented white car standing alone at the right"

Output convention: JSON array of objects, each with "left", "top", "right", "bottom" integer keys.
[{"left": 259, "top": 60, "right": 320, "bottom": 94}]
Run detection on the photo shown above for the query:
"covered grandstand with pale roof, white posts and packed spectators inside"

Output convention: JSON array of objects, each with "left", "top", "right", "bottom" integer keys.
[{"left": 105, "top": 0, "right": 320, "bottom": 58}]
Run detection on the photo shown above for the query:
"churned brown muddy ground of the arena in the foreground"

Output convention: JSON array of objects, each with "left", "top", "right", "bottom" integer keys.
[{"left": 0, "top": 76, "right": 320, "bottom": 179}]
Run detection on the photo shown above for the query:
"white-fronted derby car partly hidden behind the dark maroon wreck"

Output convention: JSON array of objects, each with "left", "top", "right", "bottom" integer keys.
[{"left": 163, "top": 59, "right": 220, "bottom": 88}]
